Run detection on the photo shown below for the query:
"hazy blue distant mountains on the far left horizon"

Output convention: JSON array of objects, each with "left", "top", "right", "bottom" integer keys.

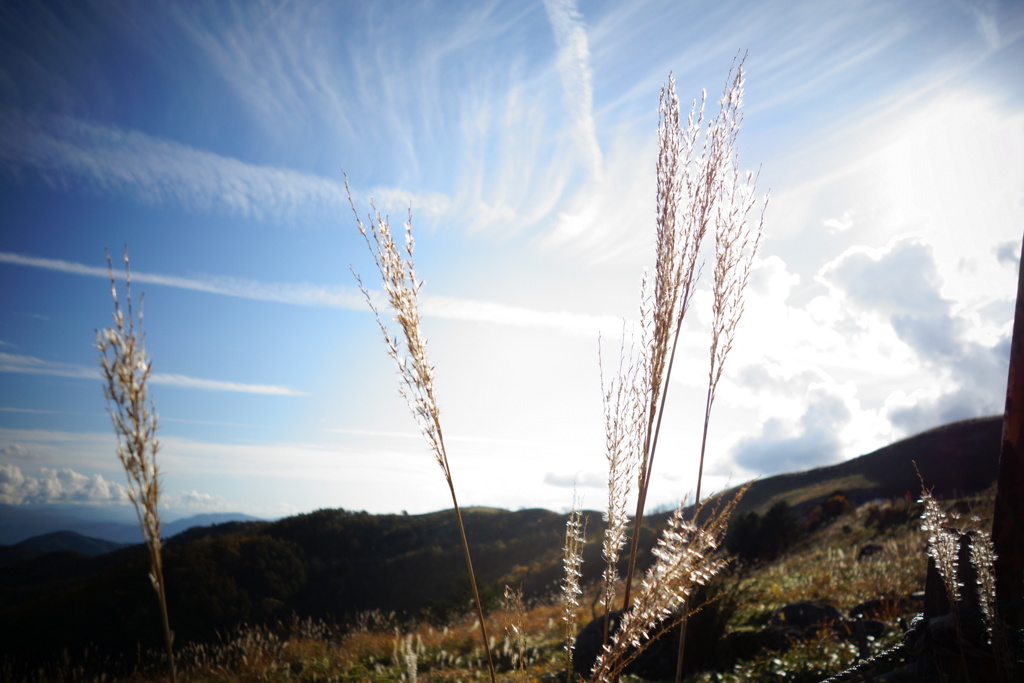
[{"left": 0, "top": 505, "right": 268, "bottom": 546}]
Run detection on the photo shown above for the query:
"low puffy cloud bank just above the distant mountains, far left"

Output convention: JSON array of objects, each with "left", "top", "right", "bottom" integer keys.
[{"left": 0, "top": 464, "right": 128, "bottom": 505}]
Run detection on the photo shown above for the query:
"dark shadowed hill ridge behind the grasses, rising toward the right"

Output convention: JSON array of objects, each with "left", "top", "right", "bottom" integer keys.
[{"left": 0, "top": 418, "right": 1001, "bottom": 660}]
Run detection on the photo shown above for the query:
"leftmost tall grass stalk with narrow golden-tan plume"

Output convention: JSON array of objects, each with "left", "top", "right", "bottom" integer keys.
[{"left": 96, "top": 248, "right": 177, "bottom": 683}]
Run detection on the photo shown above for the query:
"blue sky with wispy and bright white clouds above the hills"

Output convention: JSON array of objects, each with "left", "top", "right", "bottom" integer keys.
[{"left": 0, "top": 0, "right": 1024, "bottom": 517}]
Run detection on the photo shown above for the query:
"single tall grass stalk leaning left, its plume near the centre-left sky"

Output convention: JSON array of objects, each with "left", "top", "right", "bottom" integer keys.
[{"left": 345, "top": 178, "right": 496, "bottom": 682}]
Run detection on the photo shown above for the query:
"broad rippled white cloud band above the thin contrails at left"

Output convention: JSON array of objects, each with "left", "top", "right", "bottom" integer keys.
[{"left": 0, "top": 106, "right": 449, "bottom": 223}]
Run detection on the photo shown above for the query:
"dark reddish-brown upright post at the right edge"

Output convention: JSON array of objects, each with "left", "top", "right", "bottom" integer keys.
[{"left": 992, "top": 232, "right": 1024, "bottom": 621}]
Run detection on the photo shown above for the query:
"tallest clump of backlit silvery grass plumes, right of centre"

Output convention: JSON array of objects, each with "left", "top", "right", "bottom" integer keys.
[{"left": 581, "top": 57, "right": 767, "bottom": 680}]
